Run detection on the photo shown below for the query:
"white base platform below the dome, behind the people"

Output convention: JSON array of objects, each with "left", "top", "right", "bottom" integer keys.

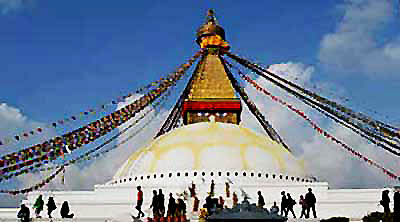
[{"left": 0, "top": 172, "right": 393, "bottom": 221}]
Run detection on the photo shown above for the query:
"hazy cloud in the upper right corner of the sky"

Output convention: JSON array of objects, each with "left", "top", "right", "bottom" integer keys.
[{"left": 319, "top": 0, "right": 400, "bottom": 77}]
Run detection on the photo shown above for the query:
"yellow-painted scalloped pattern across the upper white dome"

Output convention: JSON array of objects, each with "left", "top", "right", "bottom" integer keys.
[{"left": 116, "top": 123, "right": 304, "bottom": 177}]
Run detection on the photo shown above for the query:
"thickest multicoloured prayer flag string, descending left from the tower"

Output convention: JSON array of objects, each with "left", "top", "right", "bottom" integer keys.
[{"left": 0, "top": 51, "right": 202, "bottom": 171}]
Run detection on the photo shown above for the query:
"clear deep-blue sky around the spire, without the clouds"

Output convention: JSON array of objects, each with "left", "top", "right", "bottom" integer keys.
[{"left": 0, "top": 0, "right": 399, "bottom": 122}]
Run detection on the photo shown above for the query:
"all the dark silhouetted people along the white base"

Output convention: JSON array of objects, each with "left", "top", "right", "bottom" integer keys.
[{"left": 17, "top": 181, "right": 400, "bottom": 222}]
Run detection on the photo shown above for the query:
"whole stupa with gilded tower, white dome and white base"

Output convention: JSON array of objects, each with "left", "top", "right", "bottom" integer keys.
[{"left": 0, "top": 9, "right": 394, "bottom": 221}]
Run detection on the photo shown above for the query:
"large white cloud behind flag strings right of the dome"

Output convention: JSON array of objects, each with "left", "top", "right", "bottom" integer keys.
[{"left": 242, "top": 62, "right": 400, "bottom": 188}]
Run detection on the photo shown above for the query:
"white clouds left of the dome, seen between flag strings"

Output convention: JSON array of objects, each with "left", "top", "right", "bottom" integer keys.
[{"left": 0, "top": 95, "right": 169, "bottom": 207}]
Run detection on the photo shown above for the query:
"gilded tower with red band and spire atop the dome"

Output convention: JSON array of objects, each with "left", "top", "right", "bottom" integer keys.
[{"left": 183, "top": 10, "right": 242, "bottom": 124}]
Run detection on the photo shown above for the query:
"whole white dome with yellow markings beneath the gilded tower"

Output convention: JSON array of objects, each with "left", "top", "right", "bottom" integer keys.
[{"left": 114, "top": 122, "right": 305, "bottom": 178}]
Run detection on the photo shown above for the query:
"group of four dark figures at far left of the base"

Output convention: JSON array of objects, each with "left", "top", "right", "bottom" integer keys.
[{"left": 17, "top": 195, "right": 74, "bottom": 222}]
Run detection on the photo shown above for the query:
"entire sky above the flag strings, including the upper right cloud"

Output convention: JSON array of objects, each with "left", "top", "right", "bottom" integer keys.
[{"left": 0, "top": 0, "right": 400, "bottom": 206}]
